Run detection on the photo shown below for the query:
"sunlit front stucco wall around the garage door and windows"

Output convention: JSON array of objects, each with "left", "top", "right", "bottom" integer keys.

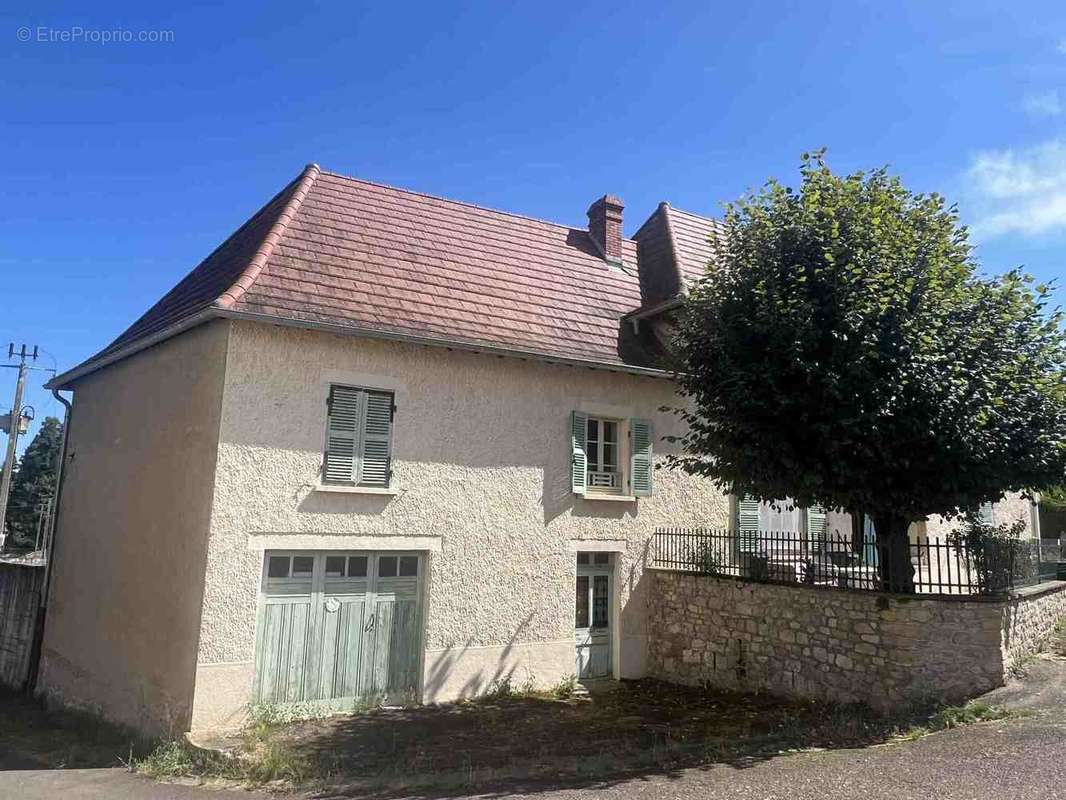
[{"left": 187, "top": 323, "right": 729, "bottom": 727}]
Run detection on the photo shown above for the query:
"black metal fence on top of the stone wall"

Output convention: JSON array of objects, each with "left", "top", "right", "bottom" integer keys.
[{"left": 653, "top": 528, "right": 1054, "bottom": 595}]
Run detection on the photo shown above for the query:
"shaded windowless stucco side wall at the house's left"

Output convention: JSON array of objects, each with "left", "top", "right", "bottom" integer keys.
[{"left": 38, "top": 322, "right": 229, "bottom": 734}]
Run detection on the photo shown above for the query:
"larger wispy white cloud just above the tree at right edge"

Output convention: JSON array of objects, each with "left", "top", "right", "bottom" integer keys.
[{"left": 966, "top": 139, "right": 1066, "bottom": 239}]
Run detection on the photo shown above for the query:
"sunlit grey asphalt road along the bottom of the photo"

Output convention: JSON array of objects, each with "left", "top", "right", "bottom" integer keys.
[{"left": 0, "top": 658, "right": 1066, "bottom": 800}]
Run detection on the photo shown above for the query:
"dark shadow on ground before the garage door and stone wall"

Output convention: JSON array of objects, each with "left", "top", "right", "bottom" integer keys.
[{"left": 244, "top": 681, "right": 925, "bottom": 798}]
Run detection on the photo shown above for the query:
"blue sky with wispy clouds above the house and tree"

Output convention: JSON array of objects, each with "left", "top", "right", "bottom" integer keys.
[{"left": 0, "top": 0, "right": 1066, "bottom": 448}]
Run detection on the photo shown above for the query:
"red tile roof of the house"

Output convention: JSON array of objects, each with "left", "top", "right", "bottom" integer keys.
[{"left": 54, "top": 164, "right": 713, "bottom": 385}]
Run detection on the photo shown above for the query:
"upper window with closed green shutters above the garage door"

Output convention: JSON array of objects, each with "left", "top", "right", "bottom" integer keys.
[{"left": 323, "top": 386, "right": 395, "bottom": 489}]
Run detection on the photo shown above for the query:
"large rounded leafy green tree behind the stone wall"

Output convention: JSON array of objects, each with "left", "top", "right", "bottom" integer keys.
[{"left": 675, "top": 153, "right": 1066, "bottom": 591}]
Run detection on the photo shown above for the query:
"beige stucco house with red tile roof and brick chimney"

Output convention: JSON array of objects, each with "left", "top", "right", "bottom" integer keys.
[{"left": 38, "top": 165, "right": 1036, "bottom": 733}]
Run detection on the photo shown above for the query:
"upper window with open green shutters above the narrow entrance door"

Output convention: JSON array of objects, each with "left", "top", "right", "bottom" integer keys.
[{"left": 570, "top": 411, "right": 651, "bottom": 497}]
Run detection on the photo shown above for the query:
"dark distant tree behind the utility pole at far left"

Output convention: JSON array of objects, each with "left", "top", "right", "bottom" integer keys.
[{"left": 7, "top": 417, "right": 63, "bottom": 547}]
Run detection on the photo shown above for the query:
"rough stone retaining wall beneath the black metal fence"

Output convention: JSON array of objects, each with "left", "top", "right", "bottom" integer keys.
[{"left": 648, "top": 570, "right": 1066, "bottom": 709}]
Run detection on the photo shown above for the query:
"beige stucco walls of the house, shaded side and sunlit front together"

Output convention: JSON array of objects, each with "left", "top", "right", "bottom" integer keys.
[{"left": 39, "top": 321, "right": 1044, "bottom": 733}]
